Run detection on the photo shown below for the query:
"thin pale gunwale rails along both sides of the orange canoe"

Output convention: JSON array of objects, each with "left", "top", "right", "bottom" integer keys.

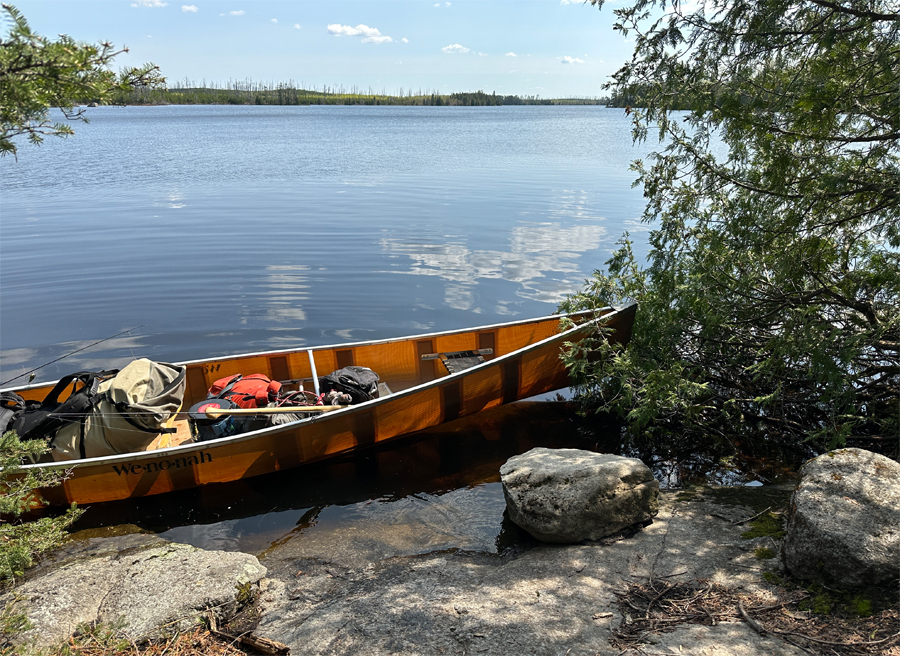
[{"left": 8, "top": 305, "right": 631, "bottom": 471}]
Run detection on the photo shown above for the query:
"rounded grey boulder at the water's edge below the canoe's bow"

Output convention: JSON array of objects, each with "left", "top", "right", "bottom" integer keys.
[{"left": 500, "top": 447, "right": 659, "bottom": 543}]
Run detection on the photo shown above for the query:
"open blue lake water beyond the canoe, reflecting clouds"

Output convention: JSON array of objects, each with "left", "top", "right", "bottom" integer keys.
[{"left": 0, "top": 106, "right": 647, "bottom": 382}]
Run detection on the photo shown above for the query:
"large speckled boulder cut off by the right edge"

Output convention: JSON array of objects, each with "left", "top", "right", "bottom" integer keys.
[{"left": 782, "top": 449, "right": 900, "bottom": 590}]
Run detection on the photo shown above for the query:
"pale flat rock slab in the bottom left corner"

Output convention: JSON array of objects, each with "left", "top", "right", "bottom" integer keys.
[{"left": 0, "top": 534, "right": 266, "bottom": 645}]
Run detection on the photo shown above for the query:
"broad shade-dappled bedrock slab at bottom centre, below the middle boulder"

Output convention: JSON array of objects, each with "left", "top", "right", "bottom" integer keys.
[{"left": 256, "top": 490, "right": 803, "bottom": 656}]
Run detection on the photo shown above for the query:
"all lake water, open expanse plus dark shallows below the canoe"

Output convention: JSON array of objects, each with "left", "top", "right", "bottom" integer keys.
[{"left": 0, "top": 107, "right": 780, "bottom": 560}]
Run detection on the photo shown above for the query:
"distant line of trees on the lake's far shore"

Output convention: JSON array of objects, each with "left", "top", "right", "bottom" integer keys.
[{"left": 109, "top": 79, "right": 603, "bottom": 107}]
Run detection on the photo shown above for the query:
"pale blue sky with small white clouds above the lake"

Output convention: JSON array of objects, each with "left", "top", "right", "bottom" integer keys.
[{"left": 13, "top": 0, "right": 632, "bottom": 98}]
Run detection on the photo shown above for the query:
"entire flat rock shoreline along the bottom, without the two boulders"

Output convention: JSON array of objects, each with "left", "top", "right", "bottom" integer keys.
[{"left": 4, "top": 452, "right": 900, "bottom": 656}]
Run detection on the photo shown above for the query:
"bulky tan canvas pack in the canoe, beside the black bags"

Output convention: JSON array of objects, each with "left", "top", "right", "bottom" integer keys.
[{"left": 50, "top": 358, "right": 186, "bottom": 460}]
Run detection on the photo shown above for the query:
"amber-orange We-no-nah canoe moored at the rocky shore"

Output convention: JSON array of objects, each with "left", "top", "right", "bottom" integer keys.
[{"left": 8, "top": 305, "right": 636, "bottom": 505}]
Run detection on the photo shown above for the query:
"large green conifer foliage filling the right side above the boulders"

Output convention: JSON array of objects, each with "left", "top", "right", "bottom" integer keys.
[{"left": 564, "top": 0, "right": 900, "bottom": 449}]
